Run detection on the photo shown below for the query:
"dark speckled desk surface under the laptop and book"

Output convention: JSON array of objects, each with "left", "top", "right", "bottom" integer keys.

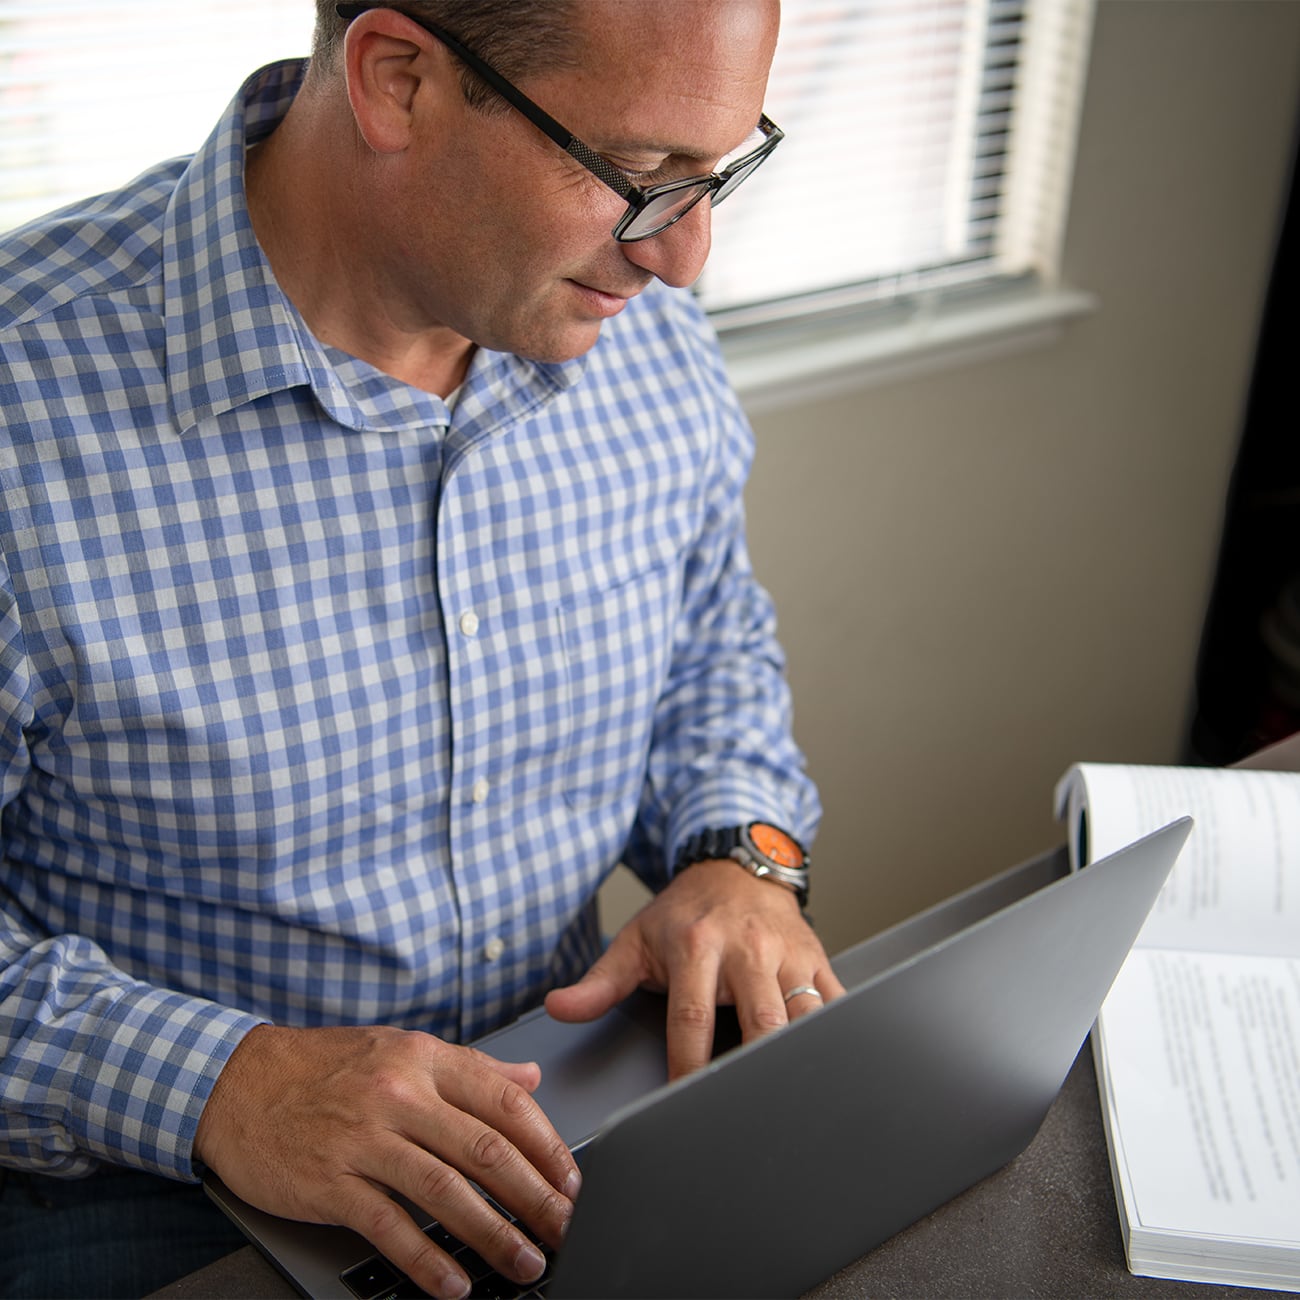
[{"left": 157, "top": 1048, "right": 1269, "bottom": 1300}]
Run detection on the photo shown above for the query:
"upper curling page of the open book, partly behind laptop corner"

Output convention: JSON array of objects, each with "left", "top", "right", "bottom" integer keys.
[{"left": 1057, "top": 763, "right": 1300, "bottom": 957}]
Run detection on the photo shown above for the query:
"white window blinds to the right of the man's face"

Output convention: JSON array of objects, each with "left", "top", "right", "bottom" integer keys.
[{"left": 701, "top": 0, "right": 1092, "bottom": 324}]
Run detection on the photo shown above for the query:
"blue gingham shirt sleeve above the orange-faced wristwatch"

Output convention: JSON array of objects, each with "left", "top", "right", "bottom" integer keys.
[{"left": 625, "top": 299, "right": 822, "bottom": 888}]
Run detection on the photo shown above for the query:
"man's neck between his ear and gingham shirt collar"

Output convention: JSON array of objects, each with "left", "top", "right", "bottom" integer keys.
[{"left": 244, "top": 91, "right": 473, "bottom": 397}]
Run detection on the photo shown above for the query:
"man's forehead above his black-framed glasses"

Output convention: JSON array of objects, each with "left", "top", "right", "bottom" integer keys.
[{"left": 535, "top": 0, "right": 779, "bottom": 157}]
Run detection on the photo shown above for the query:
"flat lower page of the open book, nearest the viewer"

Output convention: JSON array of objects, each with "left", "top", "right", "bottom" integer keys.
[{"left": 1099, "top": 950, "right": 1300, "bottom": 1242}]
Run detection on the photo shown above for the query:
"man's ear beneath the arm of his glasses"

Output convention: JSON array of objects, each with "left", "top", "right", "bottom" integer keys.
[{"left": 343, "top": 9, "right": 455, "bottom": 153}]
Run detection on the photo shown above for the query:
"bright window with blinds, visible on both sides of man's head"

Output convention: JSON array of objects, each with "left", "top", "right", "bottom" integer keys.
[{"left": 0, "top": 0, "right": 1093, "bottom": 374}]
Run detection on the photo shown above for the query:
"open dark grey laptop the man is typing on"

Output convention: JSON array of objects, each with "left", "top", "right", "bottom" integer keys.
[{"left": 207, "top": 818, "right": 1191, "bottom": 1300}]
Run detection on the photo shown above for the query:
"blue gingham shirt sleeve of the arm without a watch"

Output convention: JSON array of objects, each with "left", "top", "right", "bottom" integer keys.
[{"left": 0, "top": 558, "right": 261, "bottom": 1179}]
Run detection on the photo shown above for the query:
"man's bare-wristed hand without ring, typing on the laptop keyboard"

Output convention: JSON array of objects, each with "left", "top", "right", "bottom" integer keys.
[{"left": 194, "top": 1024, "right": 580, "bottom": 1297}]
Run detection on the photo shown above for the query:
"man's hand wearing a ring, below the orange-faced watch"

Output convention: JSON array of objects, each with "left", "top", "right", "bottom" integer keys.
[{"left": 546, "top": 861, "right": 844, "bottom": 1079}]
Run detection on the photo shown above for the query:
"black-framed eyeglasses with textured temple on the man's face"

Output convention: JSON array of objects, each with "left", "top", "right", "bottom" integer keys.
[{"left": 334, "top": 4, "right": 785, "bottom": 243}]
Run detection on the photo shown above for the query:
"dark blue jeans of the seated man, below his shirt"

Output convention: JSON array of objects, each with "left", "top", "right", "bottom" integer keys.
[{"left": 0, "top": 1165, "right": 246, "bottom": 1300}]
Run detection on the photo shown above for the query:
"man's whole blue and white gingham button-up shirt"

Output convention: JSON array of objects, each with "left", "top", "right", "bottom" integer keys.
[{"left": 0, "top": 64, "right": 818, "bottom": 1177}]
